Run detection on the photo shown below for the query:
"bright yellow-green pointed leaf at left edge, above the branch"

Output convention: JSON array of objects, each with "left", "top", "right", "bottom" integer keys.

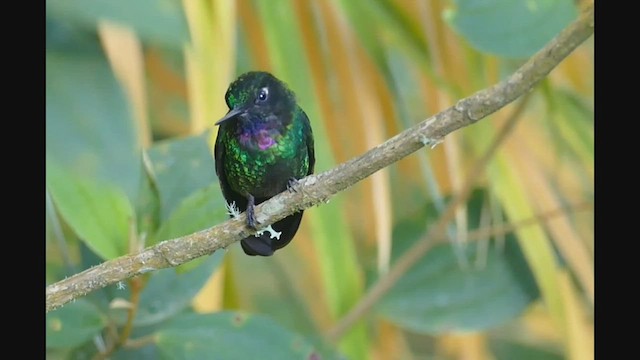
[{"left": 46, "top": 159, "right": 134, "bottom": 260}]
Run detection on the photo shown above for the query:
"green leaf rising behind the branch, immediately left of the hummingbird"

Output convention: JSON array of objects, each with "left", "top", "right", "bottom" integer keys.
[{"left": 154, "top": 182, "right": 229, "bottom": 242}]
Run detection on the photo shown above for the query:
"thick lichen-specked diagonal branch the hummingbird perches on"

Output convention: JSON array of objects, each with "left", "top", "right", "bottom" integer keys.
[{"left": 46, "top": 4, "right": 594, "bottom": 312}]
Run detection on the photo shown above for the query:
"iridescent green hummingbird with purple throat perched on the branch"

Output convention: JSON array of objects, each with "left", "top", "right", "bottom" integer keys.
[{"left": 214, "top": 71, "right": 315, "bottom": 256}]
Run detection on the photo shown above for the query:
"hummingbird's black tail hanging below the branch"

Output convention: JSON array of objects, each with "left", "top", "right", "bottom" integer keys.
[{"left": 240, "top": 211, "right": 303, "bottom": 256}]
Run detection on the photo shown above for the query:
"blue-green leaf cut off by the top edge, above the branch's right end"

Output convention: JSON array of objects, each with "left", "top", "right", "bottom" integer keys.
[{"left": 444, "top": 0, "right": 577, "bottom": 58}]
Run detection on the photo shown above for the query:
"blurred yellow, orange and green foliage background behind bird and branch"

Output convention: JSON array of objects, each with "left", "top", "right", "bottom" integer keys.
[{"left": 46, "top": 0, "right": 595, "bottom": 359}]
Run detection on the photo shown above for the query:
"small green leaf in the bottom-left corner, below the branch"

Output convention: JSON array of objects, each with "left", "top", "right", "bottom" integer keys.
[{"left": 46, "top": 299, "right": 107, "bottom": 348}]
